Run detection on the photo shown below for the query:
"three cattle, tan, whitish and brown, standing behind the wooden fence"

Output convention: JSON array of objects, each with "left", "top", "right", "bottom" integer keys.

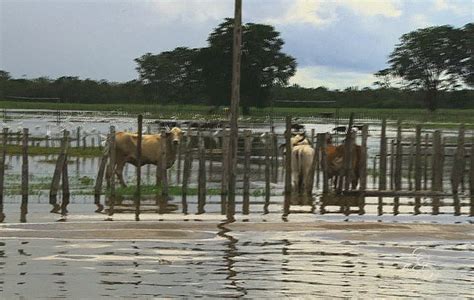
[{"left": 106, "top": 127, "right": 361, "bottom": 195}]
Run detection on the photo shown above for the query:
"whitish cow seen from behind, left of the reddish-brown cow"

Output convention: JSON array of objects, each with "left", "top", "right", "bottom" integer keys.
[{"left": 291, "top": 134, "right": 314, "bottom": 195}]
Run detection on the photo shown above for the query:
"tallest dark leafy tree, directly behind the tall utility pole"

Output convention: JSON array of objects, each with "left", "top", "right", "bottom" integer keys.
[{"left": 200, "top": 18, "right": 296, "bottom": 113}]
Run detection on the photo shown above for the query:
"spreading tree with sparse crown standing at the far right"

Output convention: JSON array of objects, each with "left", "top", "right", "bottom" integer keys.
[{"left": 376, "top": 25, "right": 472, "bottom": 111}]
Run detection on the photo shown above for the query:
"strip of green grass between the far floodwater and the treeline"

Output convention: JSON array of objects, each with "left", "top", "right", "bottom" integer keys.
[{"left": 0, "top": 101, "right": 474, "bottom": 127}]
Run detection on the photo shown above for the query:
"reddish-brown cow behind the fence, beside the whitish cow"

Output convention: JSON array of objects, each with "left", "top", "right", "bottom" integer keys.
[{"left": 326, "top": 137, "right": 361, "bottom": 189}]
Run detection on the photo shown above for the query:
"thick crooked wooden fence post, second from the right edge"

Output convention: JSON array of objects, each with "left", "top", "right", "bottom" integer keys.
[{"left": 451, "top": 124, "right": 464, "bottom": 216}]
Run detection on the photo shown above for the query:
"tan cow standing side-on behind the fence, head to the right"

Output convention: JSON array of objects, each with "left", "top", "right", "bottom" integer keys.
[{"left": 106, "top": 127, "right": 183, "bottom": 186}]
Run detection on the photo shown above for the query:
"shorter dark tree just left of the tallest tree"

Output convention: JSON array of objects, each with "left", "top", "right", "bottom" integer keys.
[{"left": 135, "top": 47, "right": 206, "bottom": 103}]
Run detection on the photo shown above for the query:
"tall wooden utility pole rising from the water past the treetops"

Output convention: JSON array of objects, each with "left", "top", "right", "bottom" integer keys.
[{"left": 226, "top": 0, "right": 242, "bottom": 221}]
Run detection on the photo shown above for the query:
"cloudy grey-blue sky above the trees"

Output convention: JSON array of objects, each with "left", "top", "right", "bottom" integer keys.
[{"left": 0, "top": 0, "right": 474, "bottom": 89}]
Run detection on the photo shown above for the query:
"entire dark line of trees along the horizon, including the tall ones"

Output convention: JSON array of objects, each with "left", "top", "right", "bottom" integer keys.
[{"left": 0, "top": 19, "right": 474, "bottom": 113}]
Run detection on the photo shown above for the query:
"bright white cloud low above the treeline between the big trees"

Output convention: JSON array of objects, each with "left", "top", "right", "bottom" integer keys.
[{"left": 290, "top": 66, "right": 376, "bottom": 89}]
